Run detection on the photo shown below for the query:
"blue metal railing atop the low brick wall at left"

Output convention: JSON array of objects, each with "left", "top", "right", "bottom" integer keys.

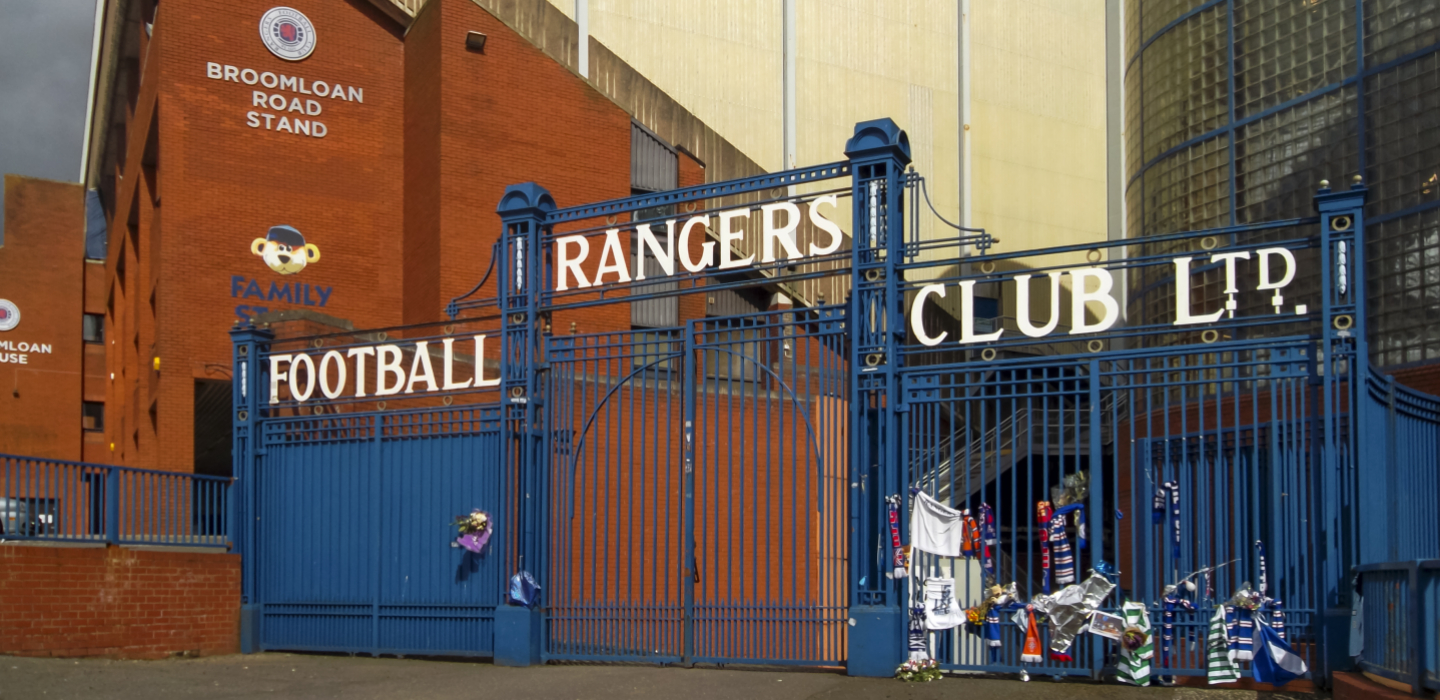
[{"left": 0, "top": 454, "right": 230, "bottom": 547}]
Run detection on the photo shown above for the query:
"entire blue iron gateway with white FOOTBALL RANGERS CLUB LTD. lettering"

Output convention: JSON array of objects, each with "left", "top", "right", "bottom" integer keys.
[{"left": 229, "top": 120, "right": 1414, "bottom": 676}]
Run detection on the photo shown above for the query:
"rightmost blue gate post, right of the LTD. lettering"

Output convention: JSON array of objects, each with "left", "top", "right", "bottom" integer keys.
[{"left": 1315, "top": 180, "right": 1370, "bottom": 676}]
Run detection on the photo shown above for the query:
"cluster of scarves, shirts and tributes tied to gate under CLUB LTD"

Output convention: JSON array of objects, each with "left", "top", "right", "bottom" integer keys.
[{"left": 910, "top": 481, "right": 1308, "bottom": 686}]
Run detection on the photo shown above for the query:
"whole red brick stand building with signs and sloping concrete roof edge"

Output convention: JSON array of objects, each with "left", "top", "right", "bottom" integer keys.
[{"left": 36, "top": 0, "right": 765, "bottom": 474}]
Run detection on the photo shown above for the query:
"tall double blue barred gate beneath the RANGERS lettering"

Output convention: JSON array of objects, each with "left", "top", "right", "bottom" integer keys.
[{"left": 544, "top": 307, "right": 848, "bottom": 665}]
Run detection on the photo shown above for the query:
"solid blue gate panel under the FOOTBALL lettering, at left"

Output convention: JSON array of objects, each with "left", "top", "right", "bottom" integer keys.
[{"left": 232, "top": 313, "right": 513, "bottom": 655}]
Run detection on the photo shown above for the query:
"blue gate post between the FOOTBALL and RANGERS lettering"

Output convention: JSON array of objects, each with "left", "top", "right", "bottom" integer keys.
[{"left": 489, "top": 183, "right": 556, "bottom": 665}]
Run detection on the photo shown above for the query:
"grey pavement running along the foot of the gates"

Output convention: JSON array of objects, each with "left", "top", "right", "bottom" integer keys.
[{"left": 0, "top": 654, "right": 1316, "bottom": 700}]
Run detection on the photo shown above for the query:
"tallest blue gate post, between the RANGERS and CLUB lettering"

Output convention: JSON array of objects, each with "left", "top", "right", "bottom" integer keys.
[{"left": 845, "top": 120, "right": 910, "bottom": 677}]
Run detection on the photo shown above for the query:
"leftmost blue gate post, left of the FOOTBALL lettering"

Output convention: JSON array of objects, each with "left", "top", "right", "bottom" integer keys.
[{"left": 226, "top": 323, "right": 275, "bottom": 654}]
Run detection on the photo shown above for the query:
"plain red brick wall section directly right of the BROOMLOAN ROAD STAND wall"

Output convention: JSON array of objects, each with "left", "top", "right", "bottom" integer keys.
[{"left": 406, "top": 0, "right": 631, "bottom": 330}]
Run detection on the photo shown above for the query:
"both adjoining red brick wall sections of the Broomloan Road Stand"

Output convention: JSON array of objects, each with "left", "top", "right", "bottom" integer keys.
[{"left": 102, "top": 0, "right": 659, "bottom": 471}]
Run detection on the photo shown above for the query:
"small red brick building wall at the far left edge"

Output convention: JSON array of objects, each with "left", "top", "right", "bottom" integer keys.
[{"left": 0, "top": 176, "right": 85, "bottom": 459}]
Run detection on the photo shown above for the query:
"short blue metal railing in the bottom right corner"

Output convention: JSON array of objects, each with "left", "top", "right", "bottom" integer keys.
[{"left": 1355, "top": 559, "right": 1440, "bottom": 696}]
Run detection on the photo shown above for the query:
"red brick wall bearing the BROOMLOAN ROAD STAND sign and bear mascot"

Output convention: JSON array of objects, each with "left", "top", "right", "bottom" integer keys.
[{"left": 107, "top": 0, "right": 405, "bottom": 471}]
